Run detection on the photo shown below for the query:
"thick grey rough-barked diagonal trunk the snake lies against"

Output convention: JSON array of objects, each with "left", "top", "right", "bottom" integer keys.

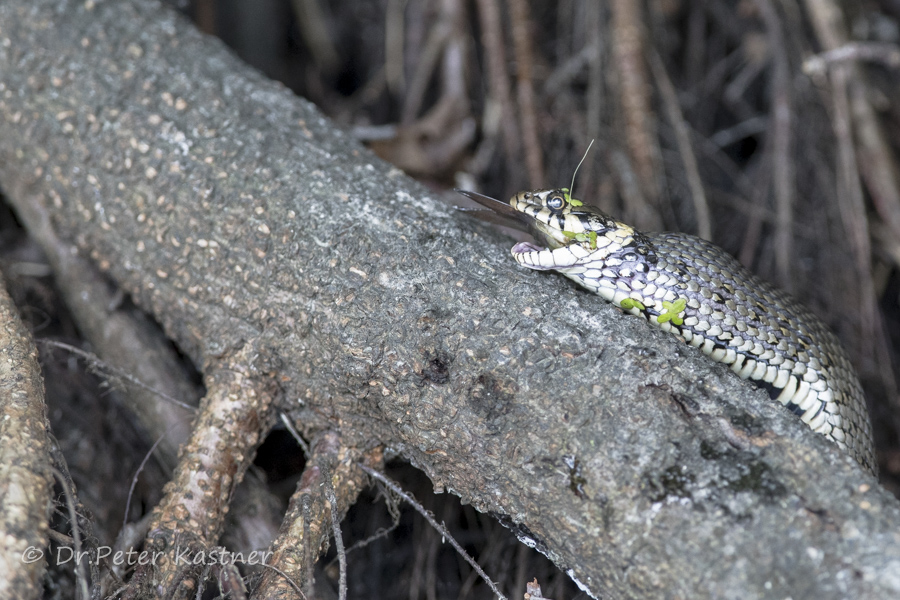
[{"left": 0, "top": 0, "right": 900, "bottom": 598}]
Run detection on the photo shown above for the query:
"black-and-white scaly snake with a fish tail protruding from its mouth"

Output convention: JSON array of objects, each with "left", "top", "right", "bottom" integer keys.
[{"left": 456, "top": 188, "right": 877, "bottom": 475}]
